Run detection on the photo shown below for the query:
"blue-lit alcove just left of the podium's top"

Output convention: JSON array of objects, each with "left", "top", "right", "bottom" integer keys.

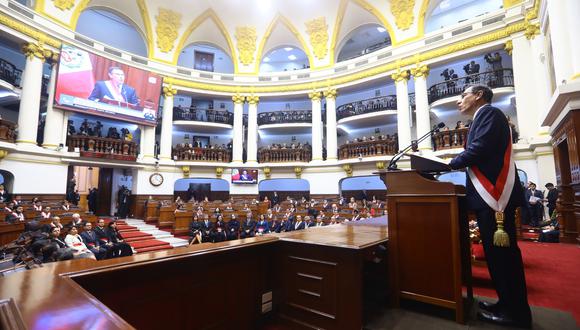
[{"left": 338, "top": 175, "right": 387, "bottom": 200}]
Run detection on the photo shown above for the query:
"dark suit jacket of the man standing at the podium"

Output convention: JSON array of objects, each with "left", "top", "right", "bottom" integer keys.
[{"left": 449, "top": 105, "right": 523, "bottom": 210}]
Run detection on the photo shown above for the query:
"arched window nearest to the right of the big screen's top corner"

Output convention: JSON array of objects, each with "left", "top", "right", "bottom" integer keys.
[{"left": 177, "top": 43, "right": 234, "bottom": 73}]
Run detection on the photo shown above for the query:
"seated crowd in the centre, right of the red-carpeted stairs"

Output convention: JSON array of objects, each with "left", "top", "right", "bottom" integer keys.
[{"left": 175, "top": 194, "right": 385, "bottom": 244}]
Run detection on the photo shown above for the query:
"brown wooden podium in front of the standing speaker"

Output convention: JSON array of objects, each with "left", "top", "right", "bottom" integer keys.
[{"left": 379, "top": 170, "right": 473, "bottom": 323}]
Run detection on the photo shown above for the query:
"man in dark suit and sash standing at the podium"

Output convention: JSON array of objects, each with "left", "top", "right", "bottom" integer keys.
[{"left": 449, "top": 85, "right": 532, "bottom": 327}]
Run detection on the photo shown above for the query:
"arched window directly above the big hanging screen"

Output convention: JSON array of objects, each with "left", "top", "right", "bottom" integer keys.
[{"left": 76, "top": 8, "right": 147, "bottom": 57}]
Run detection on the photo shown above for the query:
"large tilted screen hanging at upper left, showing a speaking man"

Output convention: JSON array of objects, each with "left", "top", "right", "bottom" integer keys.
[{"left": 54, "top": 45, "right": 162, "bottom": 126}]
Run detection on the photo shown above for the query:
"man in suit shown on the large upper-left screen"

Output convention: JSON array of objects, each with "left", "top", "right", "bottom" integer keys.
[{"left": 89, "top": 66, "right": 139, "bottom": 106}]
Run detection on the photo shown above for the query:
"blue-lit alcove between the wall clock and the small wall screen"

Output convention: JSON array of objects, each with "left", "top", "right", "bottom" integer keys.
[{"left": 173, "top": 178, "right": 230, "bottom": 201}]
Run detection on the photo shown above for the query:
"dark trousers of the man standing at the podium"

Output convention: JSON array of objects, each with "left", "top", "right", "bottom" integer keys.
[{"left": 476, "top": 206, "right": 531, "bottom": 321}]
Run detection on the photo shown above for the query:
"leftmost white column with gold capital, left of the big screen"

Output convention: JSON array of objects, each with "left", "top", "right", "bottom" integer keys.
[{"left": 16, "top": 43, "right": 52, "bottom": 145}]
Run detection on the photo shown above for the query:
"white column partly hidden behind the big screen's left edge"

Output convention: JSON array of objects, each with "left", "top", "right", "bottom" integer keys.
[{"left": 42, "top": 54, "right": 66, "bottom": 150}]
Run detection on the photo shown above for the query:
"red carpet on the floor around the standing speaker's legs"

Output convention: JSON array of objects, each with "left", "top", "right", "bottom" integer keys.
[{"left": 472, "top": 241, "right": 580, "bottom": 324}]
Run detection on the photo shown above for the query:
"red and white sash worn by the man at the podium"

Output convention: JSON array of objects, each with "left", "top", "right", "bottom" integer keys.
[{"left": 467, "top": 130, "right": 516, "bottom": 212}]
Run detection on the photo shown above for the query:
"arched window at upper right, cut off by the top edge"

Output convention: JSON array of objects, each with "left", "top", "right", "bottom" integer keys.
[{"left": 425, "top": 0, "right": 503, "bottom": 33}]
